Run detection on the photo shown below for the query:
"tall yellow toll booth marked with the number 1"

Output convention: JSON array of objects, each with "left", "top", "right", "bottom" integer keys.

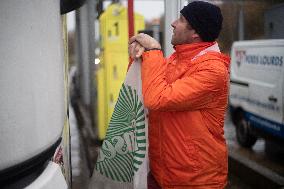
[{"left": 95, "top": 3, "right": 145, "bottom": 140}]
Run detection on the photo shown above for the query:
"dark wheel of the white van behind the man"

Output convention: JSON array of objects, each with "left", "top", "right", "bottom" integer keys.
[{"left": 236, "top": 114, "right": 257, "bottom": 148}]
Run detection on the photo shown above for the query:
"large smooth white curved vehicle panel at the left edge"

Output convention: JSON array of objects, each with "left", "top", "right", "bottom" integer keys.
[{"left": 0, "top": 0, "right": 64, "bottom": 170}]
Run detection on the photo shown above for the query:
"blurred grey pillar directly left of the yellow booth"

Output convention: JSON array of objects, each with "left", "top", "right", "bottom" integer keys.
[{"left": 76, "top": 0, "right": 96, "bottom": 106}]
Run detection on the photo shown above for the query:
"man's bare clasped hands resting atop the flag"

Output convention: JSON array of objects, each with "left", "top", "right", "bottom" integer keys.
[{"left": 129, "top": 33, "right": 161, "bottom": 58}]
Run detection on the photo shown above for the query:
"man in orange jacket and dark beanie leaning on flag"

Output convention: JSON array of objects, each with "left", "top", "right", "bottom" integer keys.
[{"left": 129, "top": 1, "right": 229, "bottom": 189}]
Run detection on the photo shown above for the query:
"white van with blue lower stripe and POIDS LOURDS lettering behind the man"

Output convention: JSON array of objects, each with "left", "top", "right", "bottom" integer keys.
[{"left": 229, "top": 39, "right": 284, "bottom": 148}]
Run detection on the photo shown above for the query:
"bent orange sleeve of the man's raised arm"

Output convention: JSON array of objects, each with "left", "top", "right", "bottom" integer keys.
[{"left": 141, "top": 51, "right": 227, "bottom": 111}]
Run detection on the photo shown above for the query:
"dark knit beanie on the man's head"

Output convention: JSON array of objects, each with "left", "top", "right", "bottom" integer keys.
[{"left": 180, "top": 1, "right": 223, "bottom": 42}]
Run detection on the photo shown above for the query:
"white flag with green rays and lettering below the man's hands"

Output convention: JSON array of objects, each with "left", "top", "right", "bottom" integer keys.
[{"left": 89, "top": 61, "right": 148, "bottom": 189}]
